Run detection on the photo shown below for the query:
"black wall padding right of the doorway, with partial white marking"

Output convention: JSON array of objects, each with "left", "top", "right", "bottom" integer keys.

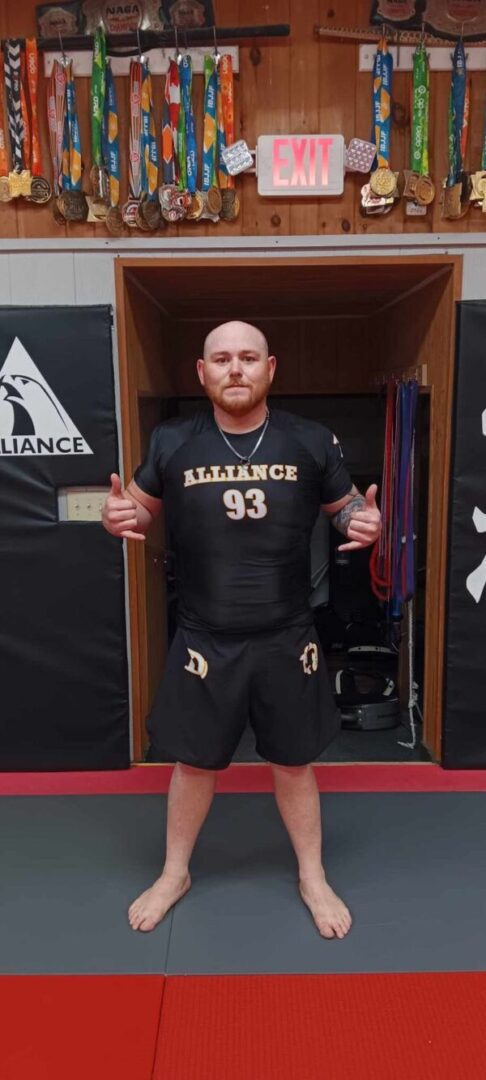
[{"left": 443, "top": 300, "right": 486, "bottom": 769}]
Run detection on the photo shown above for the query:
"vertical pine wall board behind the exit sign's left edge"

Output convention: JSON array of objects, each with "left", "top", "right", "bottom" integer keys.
[{"left": 240, "top": 0, "right": 295, "bottom": 235}]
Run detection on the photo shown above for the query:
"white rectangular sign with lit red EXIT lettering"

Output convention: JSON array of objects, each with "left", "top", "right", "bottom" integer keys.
[{"left": 256, "top": 135, "right": 345, "bottom": 198}]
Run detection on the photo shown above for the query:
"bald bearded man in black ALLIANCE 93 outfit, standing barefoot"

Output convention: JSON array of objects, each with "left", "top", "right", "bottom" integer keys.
[{"left": 104, "top": 322, "right": 380, "bottom": 937}]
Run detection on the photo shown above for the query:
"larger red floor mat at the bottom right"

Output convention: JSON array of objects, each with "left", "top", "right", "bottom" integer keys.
[{"left": 153, "top": 973, "right": 486, "bottom": 1080}]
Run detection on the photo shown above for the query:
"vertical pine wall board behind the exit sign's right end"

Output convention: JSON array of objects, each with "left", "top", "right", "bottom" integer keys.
[{"left": 314, "top": 0, "right": 360, "bottom": 234}]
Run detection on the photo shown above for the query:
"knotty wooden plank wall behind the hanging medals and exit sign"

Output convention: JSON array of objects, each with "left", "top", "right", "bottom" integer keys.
[{"left": 0, "top": 0, "right": 486, "bottom": 236}]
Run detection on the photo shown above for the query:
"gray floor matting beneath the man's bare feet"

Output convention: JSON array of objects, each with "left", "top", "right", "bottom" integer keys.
[{"left": 0, "top": 793, "right": 486, "bottom": 973}]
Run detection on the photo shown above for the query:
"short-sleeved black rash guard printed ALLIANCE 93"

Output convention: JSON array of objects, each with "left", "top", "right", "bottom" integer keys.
[{"left": 134, "top": 408, "right": 352, "bottom": 634}]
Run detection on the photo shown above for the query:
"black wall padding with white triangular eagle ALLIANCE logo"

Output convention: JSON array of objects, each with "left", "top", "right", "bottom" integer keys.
[{"left": 0, "top": 306, "right": 130, "bottom": 771}]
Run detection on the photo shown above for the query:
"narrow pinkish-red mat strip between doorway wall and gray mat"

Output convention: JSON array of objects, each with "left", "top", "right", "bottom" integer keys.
[{"left": 0, "top": 762, "right": 486, "bottom": 796}]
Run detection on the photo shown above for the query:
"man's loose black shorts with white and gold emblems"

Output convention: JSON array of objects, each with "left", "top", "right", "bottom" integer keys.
[{"left": 147, "top": 624, "right": 340, "bottom": 769}]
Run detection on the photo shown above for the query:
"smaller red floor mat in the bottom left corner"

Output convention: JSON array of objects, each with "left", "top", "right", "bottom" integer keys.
[{"left": 0, "top": 975, "right": 165, "bottom": 1080}]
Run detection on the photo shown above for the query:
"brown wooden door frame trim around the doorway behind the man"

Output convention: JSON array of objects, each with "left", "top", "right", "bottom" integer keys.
[{"left": 114, "top": 252, "right": 462, "bottom": 762}]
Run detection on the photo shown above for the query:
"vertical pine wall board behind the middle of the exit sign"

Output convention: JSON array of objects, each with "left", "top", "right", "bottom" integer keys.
[{"left": 288, "top": 0, "right": 320, "bottom": 237}]
